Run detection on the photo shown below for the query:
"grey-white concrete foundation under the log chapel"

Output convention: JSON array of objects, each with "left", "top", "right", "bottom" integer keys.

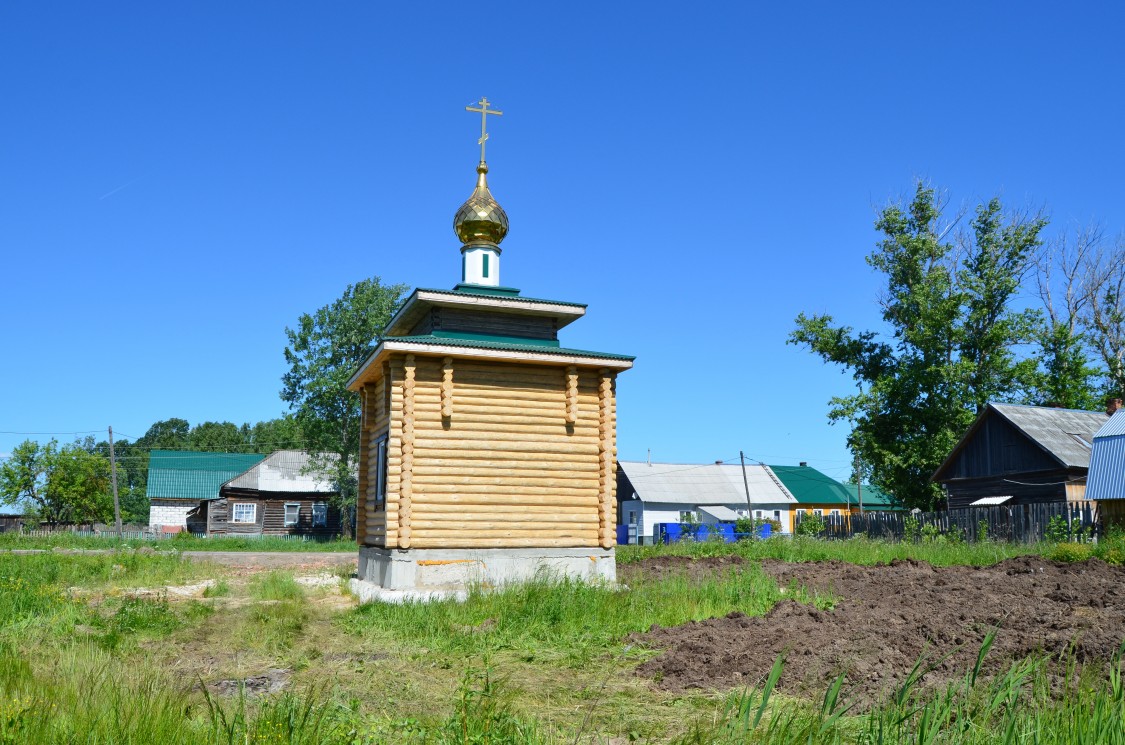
[{"left": 353, "top": 546, "right": 618, "bottom": 600}]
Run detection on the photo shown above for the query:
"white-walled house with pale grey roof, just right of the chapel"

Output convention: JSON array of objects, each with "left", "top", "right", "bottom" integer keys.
[{"left": 618, "top": 460, "right": 797, "bottom": 544}]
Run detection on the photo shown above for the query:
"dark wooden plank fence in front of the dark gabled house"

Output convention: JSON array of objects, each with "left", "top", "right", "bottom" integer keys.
[{"left": 797, "top": 502, "right": 1099, "bottom": 544}]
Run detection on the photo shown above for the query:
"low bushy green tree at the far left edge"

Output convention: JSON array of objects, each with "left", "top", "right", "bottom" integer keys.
[{"left": 0, "top": 440, "right": 113, "bottom": 524}]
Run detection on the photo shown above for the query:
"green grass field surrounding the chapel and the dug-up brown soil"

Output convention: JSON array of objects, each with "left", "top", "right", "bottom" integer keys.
[{"left": 0, "top": 540, "right": 1125, "bottom": 744}]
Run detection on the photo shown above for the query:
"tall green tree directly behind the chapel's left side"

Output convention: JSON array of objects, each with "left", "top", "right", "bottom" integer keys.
[{"left": 281, "top": 277, "right": 408, "bottom": 528}]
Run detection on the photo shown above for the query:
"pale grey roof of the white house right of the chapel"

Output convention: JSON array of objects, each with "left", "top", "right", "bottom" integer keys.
[{"left": 618, "top": 460, "right": 797, "bottom": 506}]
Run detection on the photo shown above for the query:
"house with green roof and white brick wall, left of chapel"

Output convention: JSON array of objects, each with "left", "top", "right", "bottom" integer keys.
[{"left": 145, "top": 450, "right": 266, "bottom": 530}]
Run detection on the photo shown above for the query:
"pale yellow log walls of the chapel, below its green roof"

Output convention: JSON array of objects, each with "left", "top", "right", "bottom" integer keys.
[{"left": 361, "top": 354, "right": 617, "bottom": 548}]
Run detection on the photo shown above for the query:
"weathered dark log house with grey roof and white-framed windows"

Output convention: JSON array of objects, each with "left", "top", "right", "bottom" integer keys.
[{"left": 187, "top": 450, "right": 343, "bottom": 538}]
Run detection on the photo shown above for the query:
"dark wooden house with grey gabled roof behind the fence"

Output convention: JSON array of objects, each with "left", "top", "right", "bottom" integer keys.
[{"left": 934, "top": 404, "right": 1108, "bottom": 510}]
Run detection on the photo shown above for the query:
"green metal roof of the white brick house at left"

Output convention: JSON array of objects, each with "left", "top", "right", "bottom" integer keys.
[{"left": 145, "top": 450, "right": 266, "bottom": 501}]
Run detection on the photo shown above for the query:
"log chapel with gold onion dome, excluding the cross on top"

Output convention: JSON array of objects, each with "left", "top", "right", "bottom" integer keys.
[{"left": 348, "top": 118, "right": 632, "bottom": 596}]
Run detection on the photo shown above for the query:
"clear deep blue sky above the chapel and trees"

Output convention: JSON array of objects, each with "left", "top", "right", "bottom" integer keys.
[{"left": 0, "top": 2, "right": 1125, "bottom": 477}]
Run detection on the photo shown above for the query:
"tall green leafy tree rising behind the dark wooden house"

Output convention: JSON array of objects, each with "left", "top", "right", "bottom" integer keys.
[{"left": 789, "top": 183, "right": 1045, "bottom": 510}]
